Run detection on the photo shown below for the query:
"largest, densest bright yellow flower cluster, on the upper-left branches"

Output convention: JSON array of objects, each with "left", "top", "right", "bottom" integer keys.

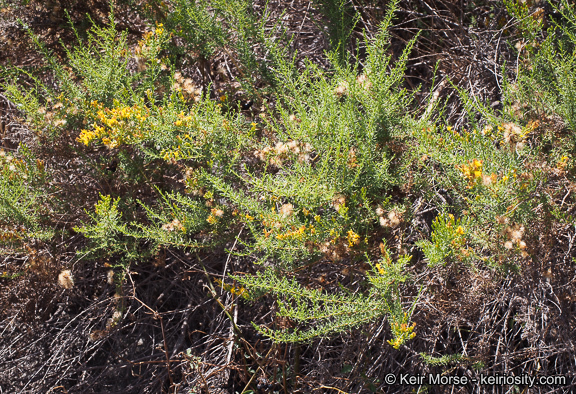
[{"left": 76, "top": 101, "right": 150, "bottom": 149}]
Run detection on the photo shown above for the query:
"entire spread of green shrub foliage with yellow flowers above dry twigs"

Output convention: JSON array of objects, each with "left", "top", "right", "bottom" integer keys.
[{"left": 0, "top": 0, "right": 576, "bottom": 356}]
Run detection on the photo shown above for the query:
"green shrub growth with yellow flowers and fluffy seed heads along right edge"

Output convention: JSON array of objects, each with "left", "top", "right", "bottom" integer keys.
[{"left": 411, "top": 2, "right": 575, "bottom": 269}]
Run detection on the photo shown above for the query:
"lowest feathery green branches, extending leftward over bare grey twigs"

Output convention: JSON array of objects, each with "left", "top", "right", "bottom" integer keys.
[{"left": 233, "top": 242, "right": 417, "bottom": 349}]
